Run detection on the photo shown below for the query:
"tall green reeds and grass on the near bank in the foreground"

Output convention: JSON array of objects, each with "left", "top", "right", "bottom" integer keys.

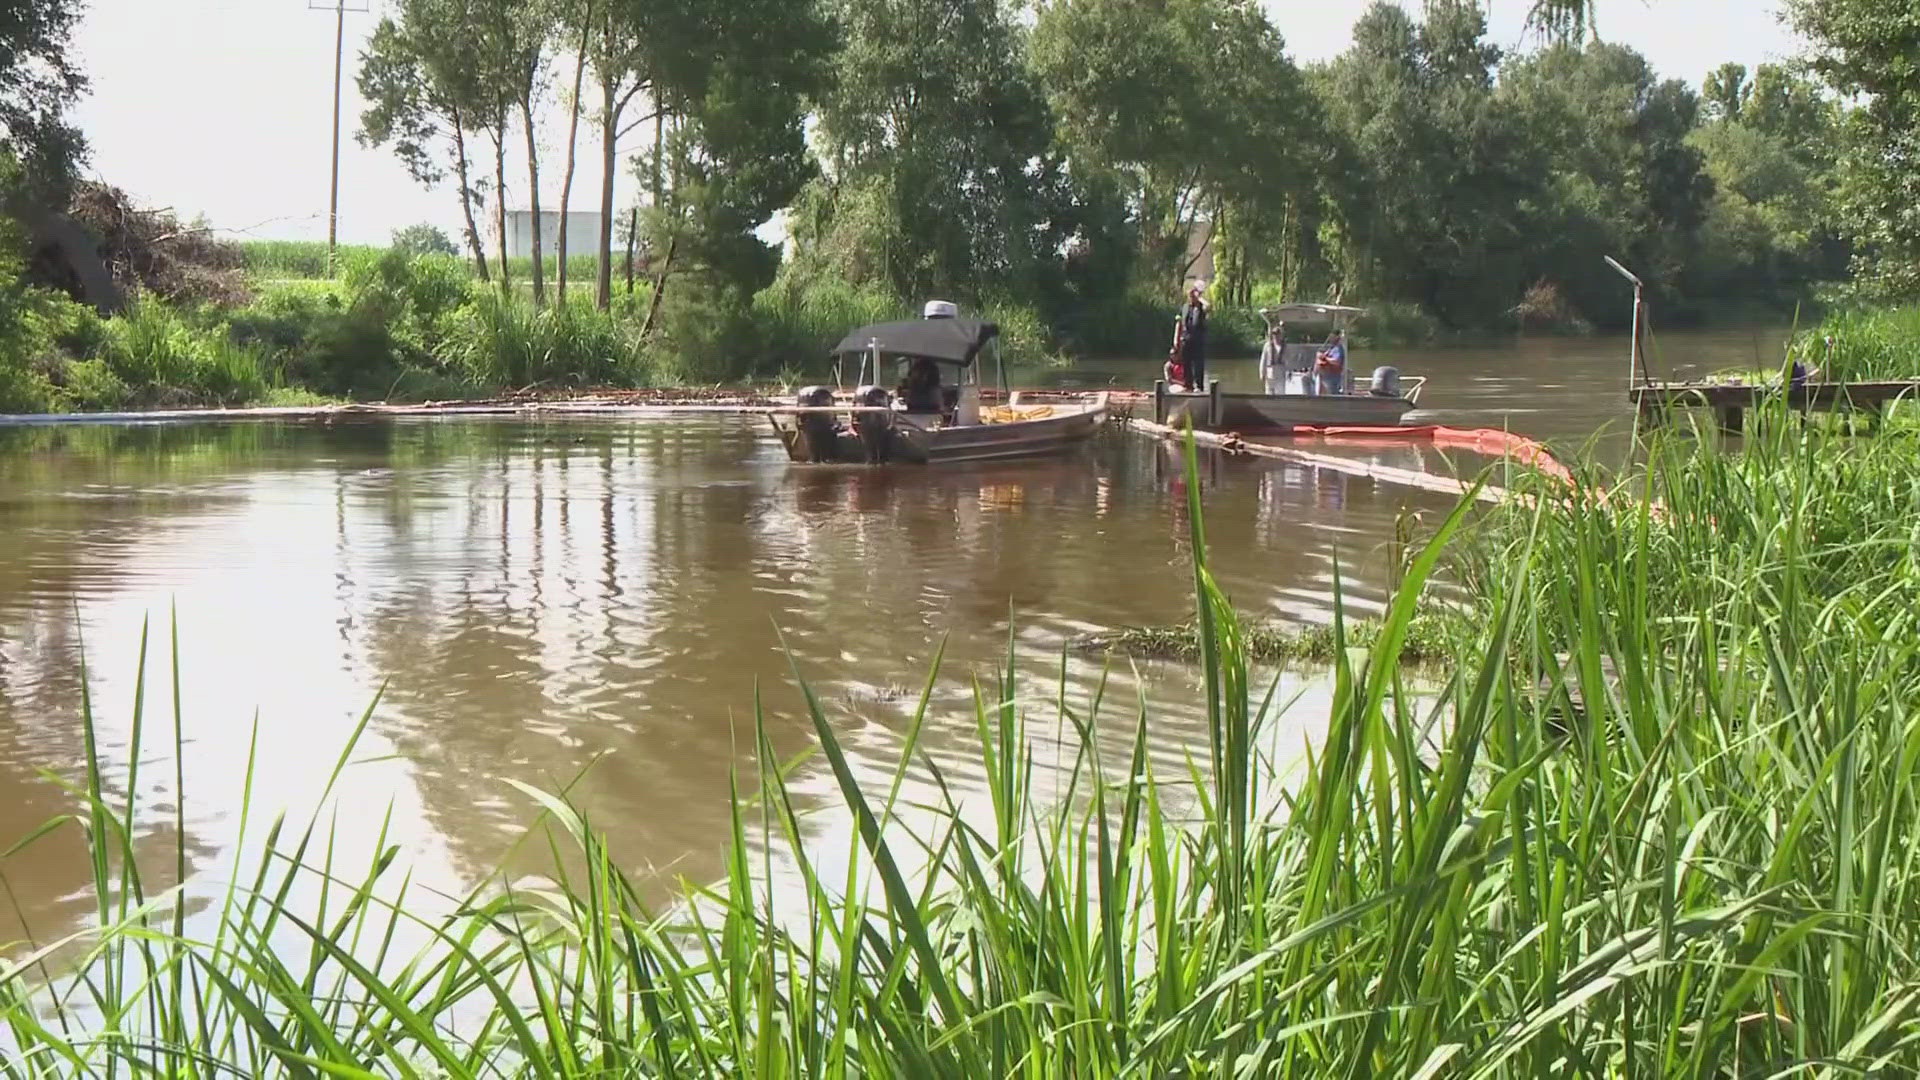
[{"left": 0, "top": 411, "right": 1920, "bottom": 1078}]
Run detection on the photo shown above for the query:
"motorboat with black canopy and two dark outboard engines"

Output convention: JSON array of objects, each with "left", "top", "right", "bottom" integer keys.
[{"left": 768, "top": 300, "right": 1106, "bottom": 465}]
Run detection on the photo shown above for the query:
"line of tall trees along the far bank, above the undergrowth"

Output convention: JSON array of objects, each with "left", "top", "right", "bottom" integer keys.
[{"left": 0, "top": 0, "right": 1920, "bottom": 352}]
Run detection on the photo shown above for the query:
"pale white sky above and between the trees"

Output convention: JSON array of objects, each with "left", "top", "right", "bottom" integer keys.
[{"left": 63, "top": 0, "right": 1797, "bottom": 242}]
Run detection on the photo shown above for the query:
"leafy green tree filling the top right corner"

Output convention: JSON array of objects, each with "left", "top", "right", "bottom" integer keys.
[{"left": 1788, "top": 0, "right": 1920, "bottom": 296}]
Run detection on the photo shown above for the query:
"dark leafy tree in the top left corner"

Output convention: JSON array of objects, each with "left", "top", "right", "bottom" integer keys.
[{"left": 0, "top": 0, "right": 86, "bottom": 206}]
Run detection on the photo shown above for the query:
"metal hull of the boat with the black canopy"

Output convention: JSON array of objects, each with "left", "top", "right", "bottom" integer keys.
[{"left": 768, "top": 394, "right": 1106, "bottom": 465}]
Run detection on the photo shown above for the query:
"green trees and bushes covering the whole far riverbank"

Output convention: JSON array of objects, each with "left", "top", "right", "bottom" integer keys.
[{"left": 0, "top": 0, "right": 1914, "bottom": 409}]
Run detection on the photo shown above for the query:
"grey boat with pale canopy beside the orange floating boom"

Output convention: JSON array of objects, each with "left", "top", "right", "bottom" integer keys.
[{"left": 1154, "top": 304, "right": 1427, "bottom": 430}]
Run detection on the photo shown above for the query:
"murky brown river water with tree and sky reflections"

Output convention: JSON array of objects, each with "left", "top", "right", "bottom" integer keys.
[{"left": 0, "top": 331, "right": 1782, "bottom": 945}]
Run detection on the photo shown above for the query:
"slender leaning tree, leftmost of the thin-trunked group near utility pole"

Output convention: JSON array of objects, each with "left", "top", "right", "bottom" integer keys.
[{"left": 357, "top": 0, "right": 488, "bottom": 281}]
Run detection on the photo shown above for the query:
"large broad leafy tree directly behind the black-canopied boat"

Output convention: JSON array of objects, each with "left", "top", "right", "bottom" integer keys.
[{"left": 793, "top": 0, "right": 1060, "bottom": 300}]
